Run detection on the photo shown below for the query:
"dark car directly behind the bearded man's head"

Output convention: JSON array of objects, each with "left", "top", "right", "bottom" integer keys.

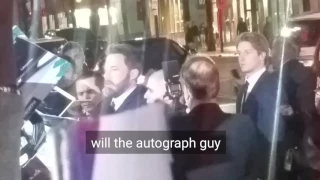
[{"left": 122, "top": 38, "right": 188, "bottom": 73}]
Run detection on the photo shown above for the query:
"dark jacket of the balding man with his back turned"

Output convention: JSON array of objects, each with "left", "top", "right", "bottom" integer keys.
[{"left": 171, "top": 104, "right": 256, "bottom": 180}]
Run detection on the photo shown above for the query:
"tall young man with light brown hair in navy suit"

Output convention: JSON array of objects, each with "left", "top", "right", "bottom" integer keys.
[{"left": 237, "top": 33, "right": 284, "bottom": 180}]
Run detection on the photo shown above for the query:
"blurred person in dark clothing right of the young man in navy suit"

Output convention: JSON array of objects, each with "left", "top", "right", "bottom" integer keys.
[{"left": 271, "top": 37, "right": 320, "bottom": 180}]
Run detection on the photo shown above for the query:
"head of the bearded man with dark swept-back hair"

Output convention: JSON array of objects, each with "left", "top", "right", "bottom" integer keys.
[{"left": 99, "top": 44, "right": 142, "bottom": 97}]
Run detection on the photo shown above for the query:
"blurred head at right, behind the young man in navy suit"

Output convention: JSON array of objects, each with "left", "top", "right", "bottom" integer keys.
[{"left": 271, "top": 37, "right": 300, "bottom": 69}]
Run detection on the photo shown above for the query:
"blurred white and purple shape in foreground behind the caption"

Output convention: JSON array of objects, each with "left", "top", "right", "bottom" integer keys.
[{"left": 64, "top": 103, "right": 173, "bottom": 180}]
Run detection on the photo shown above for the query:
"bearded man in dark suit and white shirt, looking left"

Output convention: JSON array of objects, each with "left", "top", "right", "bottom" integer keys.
[{"left": 99, "top": 44, "right": 146, "bottom": 114}]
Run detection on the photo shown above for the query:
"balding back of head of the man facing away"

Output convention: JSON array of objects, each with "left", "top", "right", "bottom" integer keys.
[{"left": 181, "top": 55, "right": 220, "bottom": 109}]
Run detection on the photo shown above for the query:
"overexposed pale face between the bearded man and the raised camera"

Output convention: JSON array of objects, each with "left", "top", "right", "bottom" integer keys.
[{"left": 144, "top": 76, "right": 169, "bottom": 104}]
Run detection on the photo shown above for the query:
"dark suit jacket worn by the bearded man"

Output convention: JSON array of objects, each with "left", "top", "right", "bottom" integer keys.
[{"left": 101, "top": 85, "right": 147, "bottom": 115}]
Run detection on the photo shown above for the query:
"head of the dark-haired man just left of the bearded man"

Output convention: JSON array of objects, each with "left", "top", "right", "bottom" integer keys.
[{"left": 76, "top": 72, "right": 104, "bottom": 113}]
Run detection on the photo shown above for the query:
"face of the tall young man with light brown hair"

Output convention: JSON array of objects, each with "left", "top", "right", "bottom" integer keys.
[{"left": 238, "top": 41, "right": 266, "bottom": 74}]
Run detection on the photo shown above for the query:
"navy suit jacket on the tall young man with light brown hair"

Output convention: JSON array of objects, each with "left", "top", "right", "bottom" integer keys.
[{"left": 237, "top": 72, "right": 286, "bottom": 179}]
